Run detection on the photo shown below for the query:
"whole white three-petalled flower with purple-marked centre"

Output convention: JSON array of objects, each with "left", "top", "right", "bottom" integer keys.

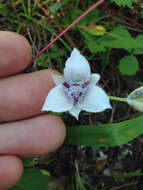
[{"left": 42, "top": 48, "right": 111, "bottom": 119}]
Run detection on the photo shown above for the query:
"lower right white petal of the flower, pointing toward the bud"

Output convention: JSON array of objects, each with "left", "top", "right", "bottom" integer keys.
[{"left": 81, "top": 84, "right": 111, "bottom": 112}]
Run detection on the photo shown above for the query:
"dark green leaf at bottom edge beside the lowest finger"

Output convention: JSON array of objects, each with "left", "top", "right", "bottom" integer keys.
[{"left": 10, "top": 168, "right": 50, "bottom": 190}]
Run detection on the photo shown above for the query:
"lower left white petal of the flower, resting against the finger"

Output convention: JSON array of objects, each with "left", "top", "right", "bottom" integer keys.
[{"left": 42, "top": 85, "right": 72, "bottom": 112}]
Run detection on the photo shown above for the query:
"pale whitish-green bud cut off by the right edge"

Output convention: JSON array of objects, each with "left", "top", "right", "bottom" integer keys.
[{"left": 127, "top": 86, "right": 143, "bottom": 112}]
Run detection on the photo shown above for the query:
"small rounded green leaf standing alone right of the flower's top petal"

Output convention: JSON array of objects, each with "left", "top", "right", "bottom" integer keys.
[{"left": 118, "top": 55, "right": 139, "bottom": 75}]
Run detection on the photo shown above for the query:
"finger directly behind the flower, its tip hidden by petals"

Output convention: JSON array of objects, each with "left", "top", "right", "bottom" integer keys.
[{"left": 0, "top": 70, "right": 55, "bottom": 122}]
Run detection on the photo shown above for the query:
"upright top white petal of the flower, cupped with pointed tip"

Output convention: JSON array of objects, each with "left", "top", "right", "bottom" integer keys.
[{"left": 64, "top": 48, "right": 91, "bottom": 82}]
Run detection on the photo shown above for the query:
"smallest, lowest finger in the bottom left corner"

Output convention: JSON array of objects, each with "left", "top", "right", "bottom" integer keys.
[{"left": 0, "top": 155, "right": 23, "bottom": 190}]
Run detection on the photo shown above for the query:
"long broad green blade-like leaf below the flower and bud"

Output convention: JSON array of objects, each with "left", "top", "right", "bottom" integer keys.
[{"left": 65, "top": 116, "right": 143, "bottom": 147}]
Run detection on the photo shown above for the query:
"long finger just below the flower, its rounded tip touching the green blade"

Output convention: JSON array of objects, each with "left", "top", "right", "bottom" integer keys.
[{"left": 0, "top": 114, "right": 65, "bottom": 157}]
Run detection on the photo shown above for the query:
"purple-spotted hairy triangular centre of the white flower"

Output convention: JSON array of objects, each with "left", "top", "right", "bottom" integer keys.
[{"left": 63, "top": 81, "right": 89, "bottom": 106}]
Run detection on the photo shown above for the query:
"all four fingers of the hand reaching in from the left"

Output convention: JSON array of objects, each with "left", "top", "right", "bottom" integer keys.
[{"left": 0, "top": 31, "right": 65, "bottom": 190}]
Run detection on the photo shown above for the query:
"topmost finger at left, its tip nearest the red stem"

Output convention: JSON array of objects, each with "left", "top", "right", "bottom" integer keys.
[{"left": 0, "top": 31, "right": 32, "bottom": 77}]
